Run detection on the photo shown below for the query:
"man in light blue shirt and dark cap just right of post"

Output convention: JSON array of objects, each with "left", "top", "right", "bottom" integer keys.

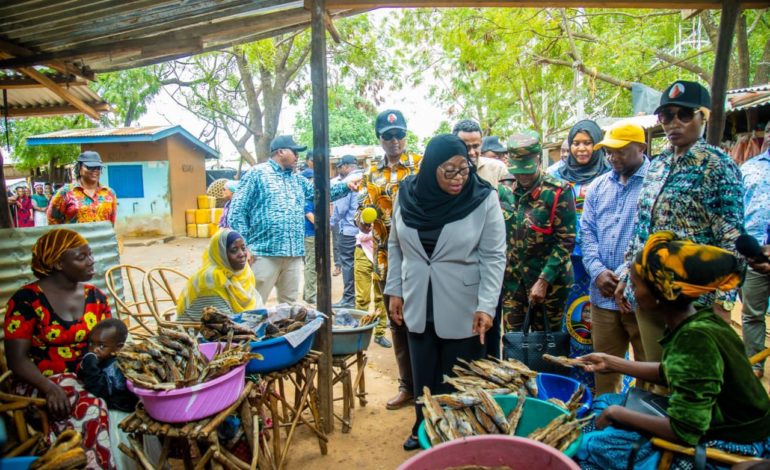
[{"left": 329, "top": 155, "right": 358, "bottom": 308}]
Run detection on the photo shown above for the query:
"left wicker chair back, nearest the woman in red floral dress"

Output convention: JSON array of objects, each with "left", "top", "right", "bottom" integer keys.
[{"left": 104, "top": 264, "right": 157, "bottom": 339}]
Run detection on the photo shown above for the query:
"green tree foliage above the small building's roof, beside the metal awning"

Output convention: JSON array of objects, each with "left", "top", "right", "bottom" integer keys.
[{"left": 89, "top": 66, "right": 162, "bottom": 127}]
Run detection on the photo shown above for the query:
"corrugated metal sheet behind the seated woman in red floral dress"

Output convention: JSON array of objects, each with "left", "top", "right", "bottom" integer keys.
[{"left": 0, "top": 222, "right": 123, "bottom": 317}]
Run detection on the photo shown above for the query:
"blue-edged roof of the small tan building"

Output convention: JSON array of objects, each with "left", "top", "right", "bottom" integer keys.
[{"left": 27, "top": 126, "right": 219, "bottom": 158}]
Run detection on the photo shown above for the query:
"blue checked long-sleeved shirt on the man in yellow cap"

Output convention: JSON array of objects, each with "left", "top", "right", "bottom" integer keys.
[{"left": 580, "top": 157, "right": 650, "bottom": 310}]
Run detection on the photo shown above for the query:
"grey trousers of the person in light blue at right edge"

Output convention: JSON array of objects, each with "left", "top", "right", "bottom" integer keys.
[{"left": 741, "top": 268, "right": 770, "bottom": 369}]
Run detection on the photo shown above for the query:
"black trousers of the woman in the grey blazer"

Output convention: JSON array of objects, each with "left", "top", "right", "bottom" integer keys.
[{"left": 407, "top": 322, "right": 486, "bottom": 436}]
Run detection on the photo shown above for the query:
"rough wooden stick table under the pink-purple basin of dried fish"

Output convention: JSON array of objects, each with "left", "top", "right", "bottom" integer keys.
[{"left": 119, "top": 381, "right": 255, "bottom": 470}]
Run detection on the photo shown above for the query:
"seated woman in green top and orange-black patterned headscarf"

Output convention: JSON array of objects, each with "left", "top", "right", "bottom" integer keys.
[{"left": 577, "top": 231, "right": 770, "bottom": 469}]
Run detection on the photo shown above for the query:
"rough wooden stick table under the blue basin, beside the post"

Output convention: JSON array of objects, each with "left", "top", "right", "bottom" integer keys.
[{"left": 249, "top": 351, "right": 329, "bottom": 470}]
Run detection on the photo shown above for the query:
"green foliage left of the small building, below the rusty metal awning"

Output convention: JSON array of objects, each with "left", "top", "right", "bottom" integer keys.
[{"left": 3, "top": 115, "right": 95, "bottom": 170}]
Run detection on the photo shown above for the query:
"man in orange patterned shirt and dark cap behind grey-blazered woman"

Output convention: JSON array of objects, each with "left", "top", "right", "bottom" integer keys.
[{"left": 356, "top": 109, "right": 422, "bottom": 410}]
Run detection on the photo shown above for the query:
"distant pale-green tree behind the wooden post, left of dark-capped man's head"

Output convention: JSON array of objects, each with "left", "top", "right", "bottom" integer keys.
[{"left": 294, "top": 86, "right": 378, "bottom": 147}]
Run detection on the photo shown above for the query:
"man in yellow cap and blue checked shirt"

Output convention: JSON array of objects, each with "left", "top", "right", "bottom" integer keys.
[{"left": 580, "top": 123, "right": 650, "bottom": 395}]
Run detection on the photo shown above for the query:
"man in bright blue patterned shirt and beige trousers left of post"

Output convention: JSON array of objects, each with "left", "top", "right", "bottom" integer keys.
[{"left": 228, "top": 135, "right": 360, "bottom": 303}]
